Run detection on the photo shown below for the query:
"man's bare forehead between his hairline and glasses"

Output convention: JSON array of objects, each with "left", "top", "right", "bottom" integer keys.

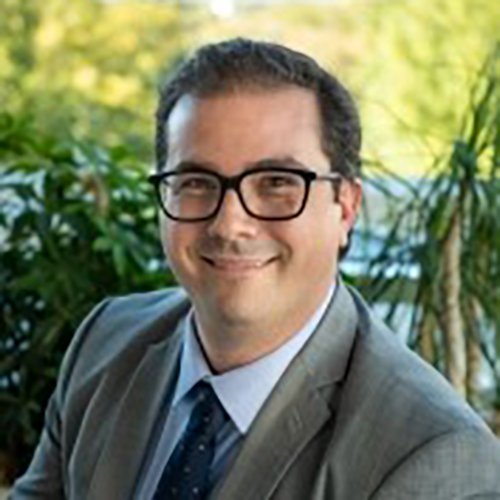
[{"left": 167, "top": 87, "right": 322, "bottom": 171}]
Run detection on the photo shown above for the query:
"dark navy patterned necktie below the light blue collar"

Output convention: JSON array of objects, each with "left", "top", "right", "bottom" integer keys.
[{"left": 153, "top": 382, "right": 229, "bottom": 500}]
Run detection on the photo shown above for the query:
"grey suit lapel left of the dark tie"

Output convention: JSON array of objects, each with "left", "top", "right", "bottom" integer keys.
[{"left": 87, "top": 310, "right": 184, "bottom": 500}]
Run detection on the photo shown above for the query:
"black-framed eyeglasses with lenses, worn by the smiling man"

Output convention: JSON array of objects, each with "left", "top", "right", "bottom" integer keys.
[{"left": 148, "top": 167, "right": 342, "bottom": 222}]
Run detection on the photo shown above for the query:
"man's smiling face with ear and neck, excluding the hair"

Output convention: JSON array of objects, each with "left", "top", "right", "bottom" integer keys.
[{"left": 160, "top": 85, "right": 360, "bottom": 373}]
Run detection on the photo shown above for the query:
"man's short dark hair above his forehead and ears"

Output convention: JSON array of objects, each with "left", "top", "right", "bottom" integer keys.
[{"left": 156, "top": 38, "right": 361, "bottom": 179}]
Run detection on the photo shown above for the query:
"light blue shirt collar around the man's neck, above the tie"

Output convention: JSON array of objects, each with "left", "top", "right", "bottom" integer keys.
[{"left": 172, "top": 283, "right": 336, "bottom": 434}]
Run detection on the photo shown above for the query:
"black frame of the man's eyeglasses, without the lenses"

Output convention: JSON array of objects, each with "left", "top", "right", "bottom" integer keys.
[{"left": 148, "top": 167, "right": 344, "bottom": 223}]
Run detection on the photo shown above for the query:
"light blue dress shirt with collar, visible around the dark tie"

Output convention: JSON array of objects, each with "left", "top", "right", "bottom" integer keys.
[{"left": 135, "top": 284, "right": 335, "bottom": 500}]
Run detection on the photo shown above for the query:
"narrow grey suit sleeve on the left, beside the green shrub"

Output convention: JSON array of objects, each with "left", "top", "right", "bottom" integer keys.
[{"left": 9, "top": 301, "right": 109, "bottom": 500}]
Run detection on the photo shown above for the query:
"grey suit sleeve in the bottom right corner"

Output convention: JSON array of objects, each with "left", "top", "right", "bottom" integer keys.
[{"left": 370, "top": 428, "right": 500, "bottom": 500}]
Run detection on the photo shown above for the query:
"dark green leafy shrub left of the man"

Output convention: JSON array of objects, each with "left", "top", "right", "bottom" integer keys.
[{"left": 0, "top": 114, "right": 173, "bottom": 481}]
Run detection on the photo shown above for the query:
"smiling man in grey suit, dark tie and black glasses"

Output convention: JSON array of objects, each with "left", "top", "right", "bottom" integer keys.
[{"left": 12, "top": 39, "right": 500, "bottom": 500}]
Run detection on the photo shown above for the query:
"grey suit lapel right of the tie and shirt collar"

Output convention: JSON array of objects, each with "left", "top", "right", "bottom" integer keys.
[{"left": 215, "top": 283, "right": 357, "bottom": 500}]
